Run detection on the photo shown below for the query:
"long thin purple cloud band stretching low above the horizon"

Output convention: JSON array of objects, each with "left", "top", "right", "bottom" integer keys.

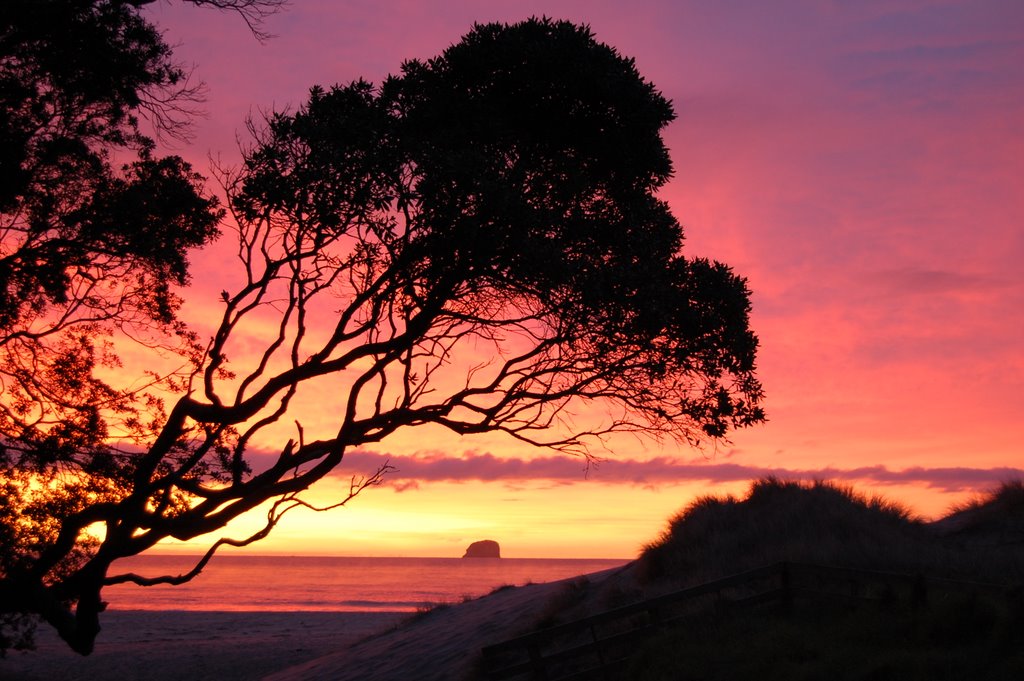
[{"left": 331, "top": 451, "right": 1024, "bottom": 492}]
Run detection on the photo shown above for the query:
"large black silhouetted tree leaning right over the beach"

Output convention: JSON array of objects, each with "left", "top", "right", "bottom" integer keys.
[{"left": 0, "top": 15, "right": 764, "bottom": 652}]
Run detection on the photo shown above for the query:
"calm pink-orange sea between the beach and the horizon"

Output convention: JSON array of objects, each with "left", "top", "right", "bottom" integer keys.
[{"left": 103, "top": 555, "right": 626, "bottom": 611}]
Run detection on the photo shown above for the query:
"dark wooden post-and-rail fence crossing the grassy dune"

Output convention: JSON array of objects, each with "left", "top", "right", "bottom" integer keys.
[{"left": 482, "top": 562, "right": 1009, "bottom": 681}]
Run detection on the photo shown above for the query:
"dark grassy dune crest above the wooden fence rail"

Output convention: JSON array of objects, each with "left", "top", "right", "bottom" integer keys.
[{"left": 638, "top": 478, "right": 1024, "bottom": 585}]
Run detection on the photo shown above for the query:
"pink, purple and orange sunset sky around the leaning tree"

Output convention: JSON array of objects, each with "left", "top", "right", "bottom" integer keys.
[{"left": 138, "top": 0, "right": 1024, "bottom": 557}]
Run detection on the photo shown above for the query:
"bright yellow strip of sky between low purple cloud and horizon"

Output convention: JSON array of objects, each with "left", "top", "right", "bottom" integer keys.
[{"left": 142, "top": 471, "right": 970, "bottom": 559}]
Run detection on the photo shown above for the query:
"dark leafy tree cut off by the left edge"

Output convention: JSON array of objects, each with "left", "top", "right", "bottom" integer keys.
[{"left": 0, "top": 0, "right": 281, "bottom": 652}]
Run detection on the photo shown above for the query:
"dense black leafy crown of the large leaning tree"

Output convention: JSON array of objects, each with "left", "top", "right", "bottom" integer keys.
[{"left": 236, "top": 19, "right": 764, "bottom": 437}]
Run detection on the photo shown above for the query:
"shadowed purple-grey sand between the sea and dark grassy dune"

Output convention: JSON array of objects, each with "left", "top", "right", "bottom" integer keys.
[{"left": 0, "top": 581, "right": 589, "bottom": 681}]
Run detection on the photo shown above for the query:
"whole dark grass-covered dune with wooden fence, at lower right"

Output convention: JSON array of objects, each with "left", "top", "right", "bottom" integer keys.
[{"left": 484, "top": 478, "right": 1024, "bottom": 681}]
